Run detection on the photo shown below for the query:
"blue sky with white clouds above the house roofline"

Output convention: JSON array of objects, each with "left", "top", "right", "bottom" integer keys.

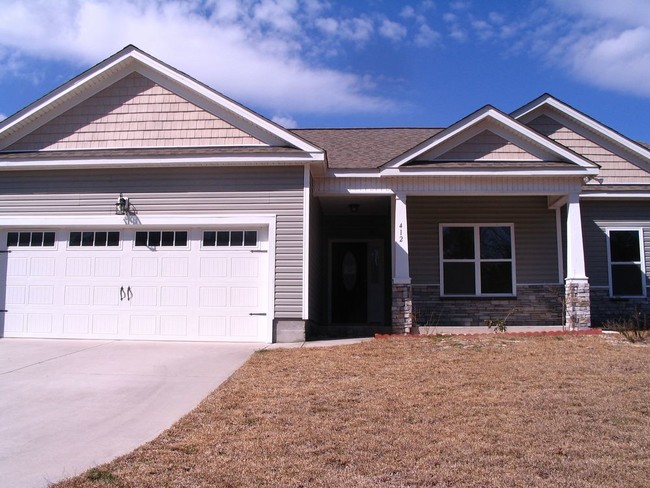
[{"left": 0, "top": 0, "right": 650, "bottom": 141}]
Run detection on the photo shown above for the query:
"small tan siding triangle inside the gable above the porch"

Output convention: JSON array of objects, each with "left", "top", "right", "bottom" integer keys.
[{"left": 436, "top": 130, "right": 541, "bottom": 161}]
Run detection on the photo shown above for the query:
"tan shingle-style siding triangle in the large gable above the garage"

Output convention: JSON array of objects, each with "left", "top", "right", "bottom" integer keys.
[{"left": 7, "top": 73, "right": 262, "bottom": 151}]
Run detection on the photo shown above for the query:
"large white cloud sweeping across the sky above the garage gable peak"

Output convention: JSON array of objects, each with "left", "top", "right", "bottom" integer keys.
[{"left": 0, "top": 0, "right": 394, "bottom": 113}]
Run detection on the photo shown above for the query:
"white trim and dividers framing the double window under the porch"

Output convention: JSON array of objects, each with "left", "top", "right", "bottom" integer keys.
[{"left": 438, "top": 222, "right": 517, "bottom": 298}]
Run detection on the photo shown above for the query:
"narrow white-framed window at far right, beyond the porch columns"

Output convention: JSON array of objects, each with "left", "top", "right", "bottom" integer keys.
[{"left": 607, "top": 229, "right": 646, "bottom": 297}]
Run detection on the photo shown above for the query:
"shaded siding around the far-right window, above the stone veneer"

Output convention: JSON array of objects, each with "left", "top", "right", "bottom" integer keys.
[{"left": 580, "top": 201, "right": 650, "bottom": 286}]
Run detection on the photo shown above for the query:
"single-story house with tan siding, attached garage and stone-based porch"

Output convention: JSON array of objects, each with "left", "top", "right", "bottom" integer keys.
[{"left": 0, "top": 46, "right": 650, "bottom": 342}]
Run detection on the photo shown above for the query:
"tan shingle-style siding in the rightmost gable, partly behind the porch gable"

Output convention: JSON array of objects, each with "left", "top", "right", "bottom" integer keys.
[{"left": 528, "top": 115, "right": 650, "bottom": 185}]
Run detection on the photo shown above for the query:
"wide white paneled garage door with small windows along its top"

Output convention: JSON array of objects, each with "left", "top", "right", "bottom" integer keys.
[{"left": 0, "top": 227, "right": 269, "bottom": 341}]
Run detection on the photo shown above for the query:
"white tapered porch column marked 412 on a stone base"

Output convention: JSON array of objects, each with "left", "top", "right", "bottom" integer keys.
[{"left": 391, "top": 192, "right": 413, "bottom": 333}]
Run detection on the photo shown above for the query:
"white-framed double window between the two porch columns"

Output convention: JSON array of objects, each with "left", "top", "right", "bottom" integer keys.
[{"left": 440, "top": 224, "right": 515, "bottom": 296}]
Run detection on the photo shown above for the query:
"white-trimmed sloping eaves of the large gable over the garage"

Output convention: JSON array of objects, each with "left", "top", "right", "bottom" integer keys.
[{"left": 0, "top": 45, "right": 324, "bottom": 161}]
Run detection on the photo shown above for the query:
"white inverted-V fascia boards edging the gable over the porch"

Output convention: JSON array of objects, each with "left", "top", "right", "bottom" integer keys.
[{"left": 382, "top": 105, "right": 597, "bottom": 173}]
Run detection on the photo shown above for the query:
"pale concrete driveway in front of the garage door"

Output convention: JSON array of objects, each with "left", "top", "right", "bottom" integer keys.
[{"left": 0, "top": 339, "right": 264, "bottom": 488}]
